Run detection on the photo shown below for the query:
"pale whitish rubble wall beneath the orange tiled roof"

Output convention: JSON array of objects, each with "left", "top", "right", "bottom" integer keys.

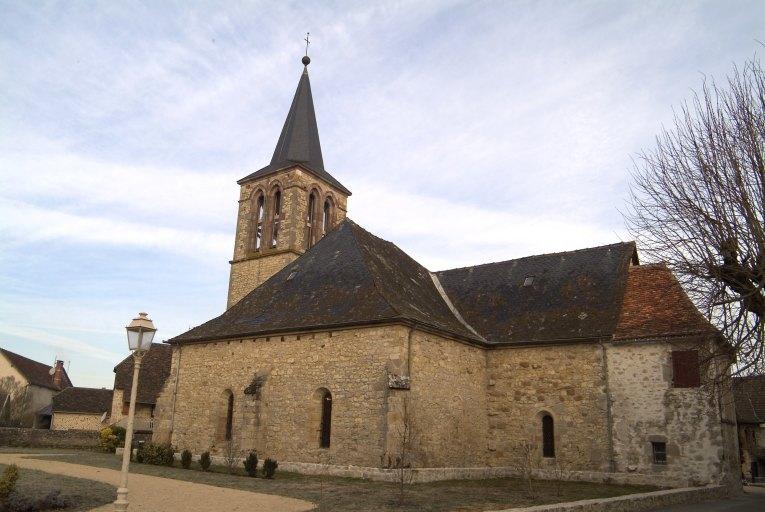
[{"left": 607, "top": 341, "right": 738, "bottom": 485}]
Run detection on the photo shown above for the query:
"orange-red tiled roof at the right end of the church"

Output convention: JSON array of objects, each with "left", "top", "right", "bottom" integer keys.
[{"left": 614, "top": 264, "right": 717, "bottom": 339}]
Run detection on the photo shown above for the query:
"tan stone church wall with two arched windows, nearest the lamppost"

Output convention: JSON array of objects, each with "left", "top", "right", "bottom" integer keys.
[{"left": 163, "top": 326, "right": 408, "bottom": 466}]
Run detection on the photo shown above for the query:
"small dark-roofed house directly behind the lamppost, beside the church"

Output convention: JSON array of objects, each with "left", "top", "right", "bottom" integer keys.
[{"left": 110, "top": 343, "right": 172, "bottom": 432}]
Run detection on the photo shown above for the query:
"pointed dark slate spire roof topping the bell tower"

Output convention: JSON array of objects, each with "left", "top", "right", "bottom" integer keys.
[{"left": 238, "top": 68, "right": 351, "bottom": 195}]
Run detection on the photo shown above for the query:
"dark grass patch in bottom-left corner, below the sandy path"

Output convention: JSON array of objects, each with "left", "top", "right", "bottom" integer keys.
[{"left": 0, "top": 464, "right": 117, "bottom": 512}]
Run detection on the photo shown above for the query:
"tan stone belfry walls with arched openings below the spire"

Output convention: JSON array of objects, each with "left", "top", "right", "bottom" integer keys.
[{"left": 228, "top": 167, "right": 347, "bottom": 307}]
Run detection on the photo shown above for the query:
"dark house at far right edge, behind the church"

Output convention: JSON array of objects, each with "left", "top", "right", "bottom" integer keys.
[{"left": 733, "top": 375, "right": 765, "bottom": 481}]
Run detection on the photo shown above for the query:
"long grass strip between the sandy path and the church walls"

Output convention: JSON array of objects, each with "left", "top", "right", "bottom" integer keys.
[{"left": 14, "top": 449, "right": 655, "bottom": 512}]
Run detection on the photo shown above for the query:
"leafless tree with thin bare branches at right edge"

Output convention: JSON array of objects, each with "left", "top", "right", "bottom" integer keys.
[{"left": 625, "top": 57, "right": 765, "bottom": 377}]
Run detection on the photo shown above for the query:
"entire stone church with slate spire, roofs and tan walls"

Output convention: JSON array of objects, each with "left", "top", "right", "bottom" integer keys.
[{"left": 154, "top": 57, "right": 739, "bottom": 486}]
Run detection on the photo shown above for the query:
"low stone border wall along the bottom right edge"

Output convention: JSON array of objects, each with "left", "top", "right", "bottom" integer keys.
[{"left": 486, "top": 485, "right": 727, "bottom": 512}]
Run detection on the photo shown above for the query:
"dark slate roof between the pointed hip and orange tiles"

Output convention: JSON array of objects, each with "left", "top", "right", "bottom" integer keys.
[{"left": 436, "top": 242, "right": 637, "bottom": 343}]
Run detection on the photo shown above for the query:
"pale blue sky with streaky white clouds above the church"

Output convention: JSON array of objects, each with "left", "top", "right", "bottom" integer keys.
[{"left": 0, "top": 0, "right": 765, "bottom": 387}]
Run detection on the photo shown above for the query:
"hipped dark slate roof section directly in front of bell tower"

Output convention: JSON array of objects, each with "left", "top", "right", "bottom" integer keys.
[{"left": 169, "top": 219, "right": 480, "bottom": 343}]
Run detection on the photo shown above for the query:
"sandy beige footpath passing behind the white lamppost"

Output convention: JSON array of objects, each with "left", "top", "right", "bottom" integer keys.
[{"left": 0, "top": 453, "right": 314, "bottom": 512}]
